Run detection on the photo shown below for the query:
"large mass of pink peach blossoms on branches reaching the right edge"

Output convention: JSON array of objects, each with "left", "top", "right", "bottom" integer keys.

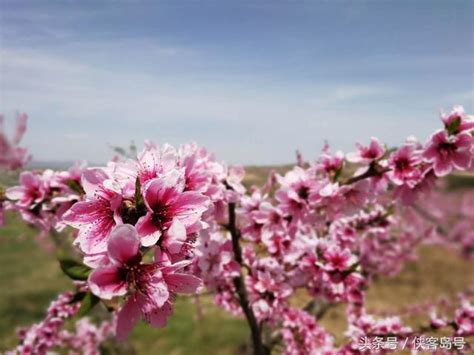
[{"left": 5, "top": 107, "right": 474, "bottom": 354}]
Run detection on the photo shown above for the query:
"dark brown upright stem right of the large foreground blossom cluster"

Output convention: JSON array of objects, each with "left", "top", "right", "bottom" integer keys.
[{"left": 228, "top": 203, "right": 269, "bottom": 355}]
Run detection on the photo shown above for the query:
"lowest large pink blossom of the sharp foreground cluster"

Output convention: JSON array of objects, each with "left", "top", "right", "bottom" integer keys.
[{"left": 88, "top": 224, "right": 201, "bottom": 340}]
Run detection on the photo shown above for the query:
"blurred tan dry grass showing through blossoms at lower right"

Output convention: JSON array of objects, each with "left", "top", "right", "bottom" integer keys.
[{"left": 321, "top": 246, "right": 474, "bottom": 341}]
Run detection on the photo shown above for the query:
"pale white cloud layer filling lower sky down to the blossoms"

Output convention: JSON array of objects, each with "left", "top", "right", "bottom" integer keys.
[{"left": 0, "top": 43, "right": 460, "bottom": 163}]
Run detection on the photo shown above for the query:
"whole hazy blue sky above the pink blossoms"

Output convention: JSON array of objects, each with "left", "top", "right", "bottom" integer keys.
[{"left": 0, "top": 0, "right": 474, "bottom": 164}]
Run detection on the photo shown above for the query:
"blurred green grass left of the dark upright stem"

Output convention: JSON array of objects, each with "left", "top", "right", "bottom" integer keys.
[{"left": 0, "top": 215, "right": 247, "bottom": 354}]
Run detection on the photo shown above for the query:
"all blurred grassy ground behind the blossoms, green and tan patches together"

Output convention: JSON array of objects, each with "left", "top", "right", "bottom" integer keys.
[{"left": 0, "top": 168, "right": 474, "bottom": 355}]
